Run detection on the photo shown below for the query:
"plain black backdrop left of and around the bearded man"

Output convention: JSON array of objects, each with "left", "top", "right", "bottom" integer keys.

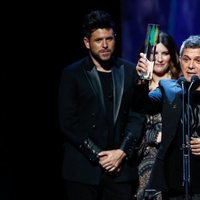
[{"left": 8, "top": 0, "right": 121, "bottom": 200}]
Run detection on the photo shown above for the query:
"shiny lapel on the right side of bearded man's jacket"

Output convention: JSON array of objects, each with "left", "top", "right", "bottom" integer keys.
[{"left": 112, "top": 65, "right": 124, "bottom": 124}]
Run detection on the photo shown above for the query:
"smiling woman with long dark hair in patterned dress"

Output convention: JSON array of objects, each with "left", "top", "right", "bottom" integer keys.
[{"left": 134, "top": 31, "right": 180, "bottom": 200}]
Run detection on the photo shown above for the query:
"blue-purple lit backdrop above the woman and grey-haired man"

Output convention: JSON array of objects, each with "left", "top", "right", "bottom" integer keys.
[{"left": 121, "top": 0, "right": 200, "bottom": 62}]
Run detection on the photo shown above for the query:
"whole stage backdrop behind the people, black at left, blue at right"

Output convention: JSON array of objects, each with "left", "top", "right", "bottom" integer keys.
[{"left": 6, "top": 0, "right": 200, "bottom": 200}]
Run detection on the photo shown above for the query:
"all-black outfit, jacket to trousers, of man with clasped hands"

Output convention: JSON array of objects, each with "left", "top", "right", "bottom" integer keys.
[{"left": 59, "top": 57, "right": 144, "bottom": 200}]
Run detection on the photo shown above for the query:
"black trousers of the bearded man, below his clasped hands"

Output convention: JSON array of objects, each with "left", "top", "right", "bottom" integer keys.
[{"left": 64, "top": 175, "right": 137, "bottom": 200}]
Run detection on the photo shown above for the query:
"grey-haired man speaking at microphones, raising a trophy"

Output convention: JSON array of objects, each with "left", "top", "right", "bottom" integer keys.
[{"left": 136, "top": 35, "right": 200, "bottom": 200}]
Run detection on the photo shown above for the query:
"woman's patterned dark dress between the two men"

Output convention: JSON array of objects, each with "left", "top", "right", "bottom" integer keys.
[{"left": 135, "top": 113, "right": 162, "bottom": 200}]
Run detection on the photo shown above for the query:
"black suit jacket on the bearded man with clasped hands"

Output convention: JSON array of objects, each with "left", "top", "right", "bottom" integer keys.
[{"left": 59, "top": 57, "right": 144, "bottom": 184}]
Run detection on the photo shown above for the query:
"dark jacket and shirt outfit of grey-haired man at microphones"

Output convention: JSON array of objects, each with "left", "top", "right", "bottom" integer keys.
[{"left": 135, "top": 80, "right": 200, "bottom": 198}]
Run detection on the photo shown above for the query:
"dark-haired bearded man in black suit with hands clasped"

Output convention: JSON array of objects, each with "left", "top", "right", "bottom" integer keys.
[{"left": 59, "top": 10, "right": 144, "bottom": 200}]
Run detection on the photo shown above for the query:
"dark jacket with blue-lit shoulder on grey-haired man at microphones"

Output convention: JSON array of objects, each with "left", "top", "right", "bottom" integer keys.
[{"left": 138, "top": 80, "right": 187, "bottom": 192}]
